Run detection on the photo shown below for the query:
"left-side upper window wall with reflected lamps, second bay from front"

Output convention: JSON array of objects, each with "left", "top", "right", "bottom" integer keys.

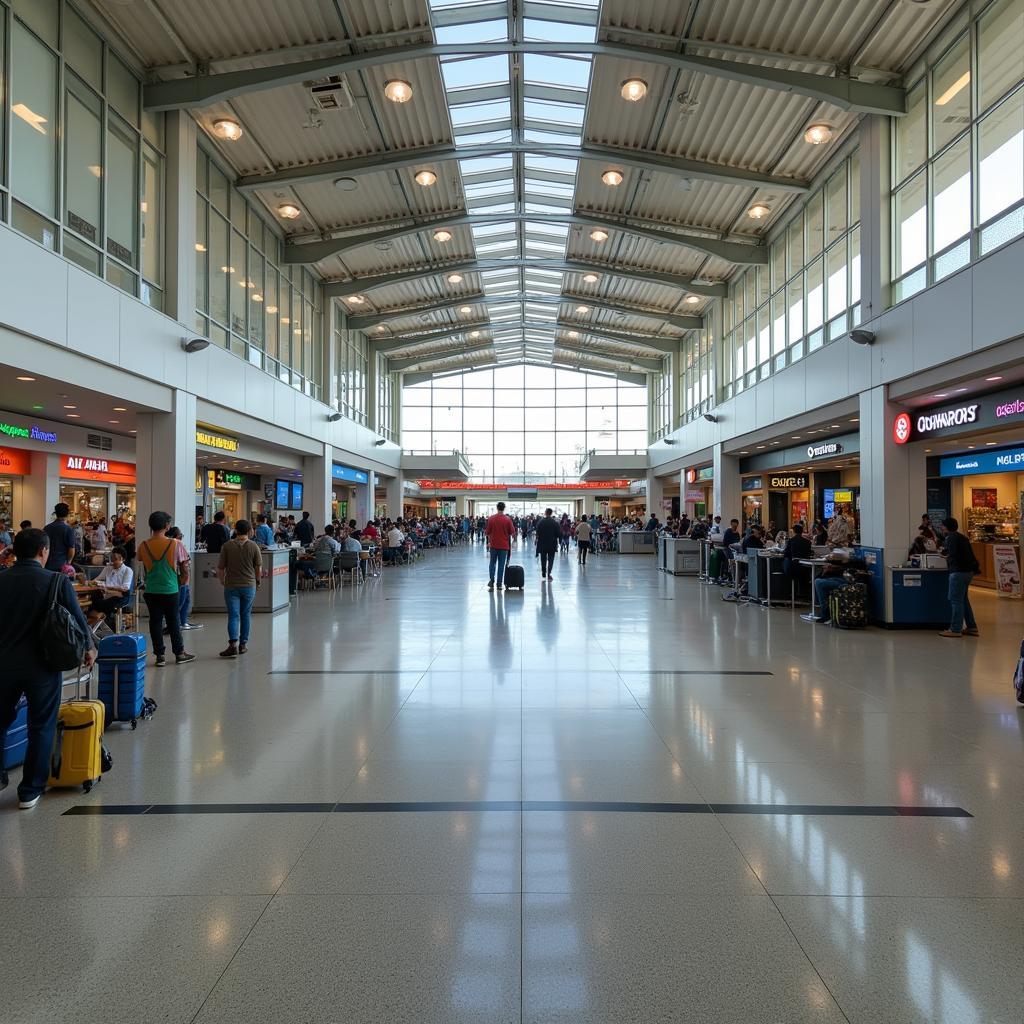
[{"left": 196, "top": 147, "right": 324, "bottom": 398}]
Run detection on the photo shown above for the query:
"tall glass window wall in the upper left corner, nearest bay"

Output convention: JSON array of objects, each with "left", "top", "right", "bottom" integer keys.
[{"left": 0, "top": 0, "right": 165, "bottom": 309}]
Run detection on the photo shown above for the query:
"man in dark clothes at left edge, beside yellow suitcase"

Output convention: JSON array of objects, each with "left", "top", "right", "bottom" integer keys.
[{"left": 0, "top": 529, "right": 96, "bottom": 811}]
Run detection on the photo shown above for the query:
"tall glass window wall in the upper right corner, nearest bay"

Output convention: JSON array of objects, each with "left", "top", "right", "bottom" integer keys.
[{"left": 892, "top": 0, "right": 1024, "bottom": 302}]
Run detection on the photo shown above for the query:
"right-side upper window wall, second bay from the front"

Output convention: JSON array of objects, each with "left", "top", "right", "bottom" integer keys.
[{"left": 724, "top": 152, "right": 860, "bottom": 397}]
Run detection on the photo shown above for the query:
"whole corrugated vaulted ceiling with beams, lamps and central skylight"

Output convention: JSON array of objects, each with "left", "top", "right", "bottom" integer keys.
[{"left": 101, "top": 0, "right": 955, "bottom": 373}]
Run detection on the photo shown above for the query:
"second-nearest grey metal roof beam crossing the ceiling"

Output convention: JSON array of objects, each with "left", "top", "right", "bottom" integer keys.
[{"left": 236, "top": 142, "right": 809, "bottom": 193}]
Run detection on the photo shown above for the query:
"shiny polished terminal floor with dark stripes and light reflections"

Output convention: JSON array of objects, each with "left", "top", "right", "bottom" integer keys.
[{"left": 0, "top": 548, "right": 1024, "bottom": 1024}]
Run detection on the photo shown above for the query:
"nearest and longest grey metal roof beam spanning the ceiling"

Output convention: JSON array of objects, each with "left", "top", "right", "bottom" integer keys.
[{"left": 143, "top": 40, "right": 906, "bottom": 115}]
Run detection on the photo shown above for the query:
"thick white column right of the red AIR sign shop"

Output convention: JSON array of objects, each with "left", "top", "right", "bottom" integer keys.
[{"left": 135, "top": 390, "right": 196, "bottom": 550}]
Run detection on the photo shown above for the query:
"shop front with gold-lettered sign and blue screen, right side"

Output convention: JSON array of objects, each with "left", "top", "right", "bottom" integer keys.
[{"left": 739, "top": 433, "right": 860, "bottom": 535}]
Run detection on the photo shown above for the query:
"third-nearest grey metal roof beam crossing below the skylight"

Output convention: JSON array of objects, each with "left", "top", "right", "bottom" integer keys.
[{"left": 283, "top": 213, "right": 768, "bottom": 265}]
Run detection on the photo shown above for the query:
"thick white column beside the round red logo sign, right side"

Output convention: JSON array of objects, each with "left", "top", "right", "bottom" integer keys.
[{"left": 860, "top": 385, "right": 928, "bottom": 562}]
